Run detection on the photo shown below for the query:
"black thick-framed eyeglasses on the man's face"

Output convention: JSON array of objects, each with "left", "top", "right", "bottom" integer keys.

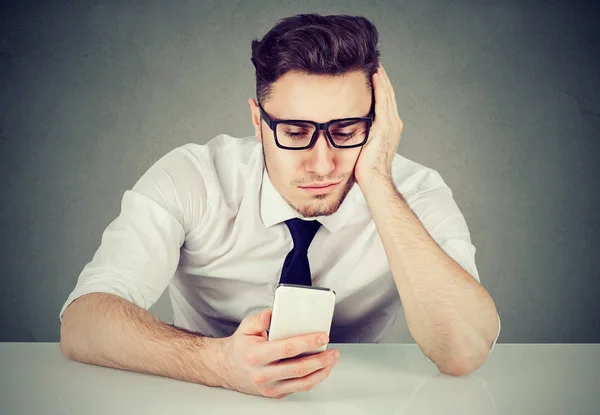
[{"left": 258, "top": 100, "right": 375, "bottom": 150}]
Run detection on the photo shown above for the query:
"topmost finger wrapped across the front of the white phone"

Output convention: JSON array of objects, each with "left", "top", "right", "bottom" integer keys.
[{"left": 256, "top": 333, "right": 329, "bottom": 365}]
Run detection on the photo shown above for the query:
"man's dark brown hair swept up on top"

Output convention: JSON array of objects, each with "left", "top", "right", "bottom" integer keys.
[{"left": 251, "top": 14, "right": 379, "bottom": 103}]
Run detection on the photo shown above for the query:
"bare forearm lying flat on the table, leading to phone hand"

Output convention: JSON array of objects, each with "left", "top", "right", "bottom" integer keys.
[{"left": 60, "top": 293, "right": 221, "bottom": 386}]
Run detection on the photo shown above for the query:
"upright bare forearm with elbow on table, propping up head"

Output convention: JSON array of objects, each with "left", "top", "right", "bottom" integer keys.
[{"left": 365, "top": 180, "right": 498, "bottom": 372}]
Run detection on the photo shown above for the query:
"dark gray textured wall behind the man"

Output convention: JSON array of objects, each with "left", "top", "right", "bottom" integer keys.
[{"left": 0, "top": 0, "right": 600, "bottom": 343}]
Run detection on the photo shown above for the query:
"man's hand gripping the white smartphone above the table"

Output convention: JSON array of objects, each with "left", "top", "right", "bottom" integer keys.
[{"left": 219, "top": 309, "right": 339, "bottom": 399}]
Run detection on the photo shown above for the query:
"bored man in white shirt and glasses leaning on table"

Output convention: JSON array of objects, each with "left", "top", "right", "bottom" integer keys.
[{"left": 60, "top": 15, "right": 500, "bottom": 398}]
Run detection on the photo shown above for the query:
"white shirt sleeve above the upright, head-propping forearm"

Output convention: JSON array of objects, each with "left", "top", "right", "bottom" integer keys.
[{"left": 407, "top": 170, "right": 500, "bottom": 353}]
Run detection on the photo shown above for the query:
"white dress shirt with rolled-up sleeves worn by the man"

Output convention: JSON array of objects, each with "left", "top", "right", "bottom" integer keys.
[{"left": 60, "top": 134, "right": 497, "bottom": 344}]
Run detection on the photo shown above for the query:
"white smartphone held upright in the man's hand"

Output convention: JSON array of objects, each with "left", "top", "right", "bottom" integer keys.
[{"left": 268, "top": 284, "right": 335, "bottom": 357}]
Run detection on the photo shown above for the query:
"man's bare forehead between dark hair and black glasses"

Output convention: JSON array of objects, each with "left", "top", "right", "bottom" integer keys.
[{"left": 264, "top": 71, "right": 371, "bottom": 122}]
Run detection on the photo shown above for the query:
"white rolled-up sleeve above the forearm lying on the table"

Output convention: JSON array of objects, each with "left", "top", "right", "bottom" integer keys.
[{"left": 59, "top": 148, "right": 205, "bottom": 321}]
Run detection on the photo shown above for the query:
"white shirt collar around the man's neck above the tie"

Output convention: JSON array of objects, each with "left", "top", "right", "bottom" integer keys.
[{"left": 260, "top": 168, "right": 358, "bottom": 232}]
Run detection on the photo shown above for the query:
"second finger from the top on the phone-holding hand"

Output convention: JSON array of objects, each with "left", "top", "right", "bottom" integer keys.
[{"left": 255, "top": 350, "right": 340, "bottom": 384}]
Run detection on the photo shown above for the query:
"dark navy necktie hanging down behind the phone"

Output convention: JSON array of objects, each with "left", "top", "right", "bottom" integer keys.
[{"left": 279, "top": 219, "right": 321, "bottom": 285}]
